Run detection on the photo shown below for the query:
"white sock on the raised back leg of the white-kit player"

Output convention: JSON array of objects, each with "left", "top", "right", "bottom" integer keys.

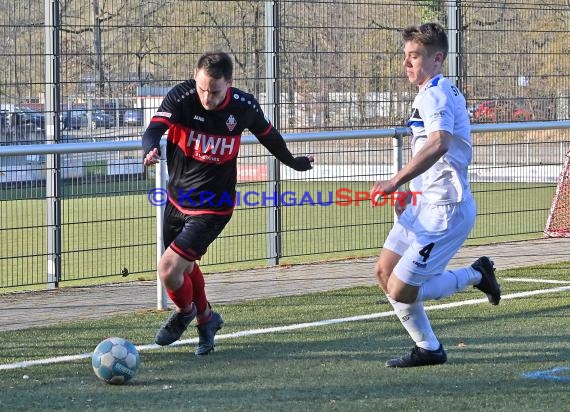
[{"left": 417, "top": 266, "right": 481, "bottom": 302}]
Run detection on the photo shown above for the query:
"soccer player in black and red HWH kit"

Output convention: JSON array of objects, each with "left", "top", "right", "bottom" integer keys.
[{"left": 142, "top": 52, "right": 313, "bottom": 356}]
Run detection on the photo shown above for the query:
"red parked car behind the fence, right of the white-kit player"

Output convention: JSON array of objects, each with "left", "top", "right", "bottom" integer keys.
[{"left": 473, "top": 98, "right": 534, "bottom": 123}]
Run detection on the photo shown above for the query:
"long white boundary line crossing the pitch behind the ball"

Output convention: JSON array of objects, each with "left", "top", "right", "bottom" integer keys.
[{"left": 0, "top": 284, "right": 570, "bottom": 370}]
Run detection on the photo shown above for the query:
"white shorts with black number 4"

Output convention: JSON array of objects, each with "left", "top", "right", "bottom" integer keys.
[{"left": 384, "top": 197, "right": 477, "bottom": 286}]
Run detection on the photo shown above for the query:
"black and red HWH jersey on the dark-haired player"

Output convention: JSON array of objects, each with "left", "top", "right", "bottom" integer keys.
[{"left": 143, "top": 80, "right": 284, "bottom": 214}]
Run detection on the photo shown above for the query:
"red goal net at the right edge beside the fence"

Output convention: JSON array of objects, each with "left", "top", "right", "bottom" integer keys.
[{"left": 544, "top": 150, "right": 570, "bottom": 237}]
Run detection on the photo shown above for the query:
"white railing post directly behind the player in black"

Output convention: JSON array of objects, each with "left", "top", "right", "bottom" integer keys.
[{"left": 154, "top": 141, "right": 168, "bottom": 310}]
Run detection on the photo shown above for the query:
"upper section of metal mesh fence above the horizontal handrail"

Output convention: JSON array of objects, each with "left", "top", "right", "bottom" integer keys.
[{"left": 0, "top": 0, "right": 570, "bottom": 138}]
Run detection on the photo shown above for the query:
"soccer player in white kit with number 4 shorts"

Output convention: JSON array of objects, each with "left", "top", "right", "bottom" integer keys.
[{"left": 370, "top": 23, "right": 501, "bottom": 368}]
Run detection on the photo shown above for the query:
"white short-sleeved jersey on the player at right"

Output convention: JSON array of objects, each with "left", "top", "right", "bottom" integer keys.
[{"left": 408, "top": 75, "right": 473, "bottom": 204}]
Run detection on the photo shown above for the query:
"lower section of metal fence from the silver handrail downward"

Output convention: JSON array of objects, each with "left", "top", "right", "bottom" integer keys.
[{"left": 0, "top": 121, "right": 570, "bottom": 290}]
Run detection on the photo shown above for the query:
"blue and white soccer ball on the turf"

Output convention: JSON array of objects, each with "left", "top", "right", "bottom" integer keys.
[{"left": 91, "top": 338, "right": 140, "bottom": 385}]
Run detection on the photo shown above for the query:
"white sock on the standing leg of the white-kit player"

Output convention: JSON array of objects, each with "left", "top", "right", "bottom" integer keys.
[{"left": 386, "top": 295, "right": 439, "bottom": 350}]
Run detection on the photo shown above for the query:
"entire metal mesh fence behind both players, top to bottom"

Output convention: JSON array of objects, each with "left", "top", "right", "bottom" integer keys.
[{"left": 0, "top": 0, "right": 570, "bottom": 289}]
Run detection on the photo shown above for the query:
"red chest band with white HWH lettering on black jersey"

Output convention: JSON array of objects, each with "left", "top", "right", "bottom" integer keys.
[{"left": 168, "top": 124, "right": 241, "bottom": 164}]
